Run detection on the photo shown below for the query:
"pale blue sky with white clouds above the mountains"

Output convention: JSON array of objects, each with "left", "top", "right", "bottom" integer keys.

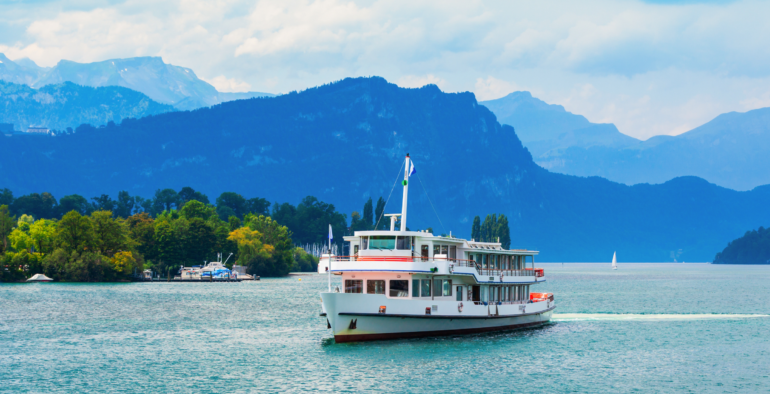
[{"left": 0, "top": 0, "right": 770, "bottom": 139}]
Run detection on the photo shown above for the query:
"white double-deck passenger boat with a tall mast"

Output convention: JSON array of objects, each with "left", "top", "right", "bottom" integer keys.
[{"left": 321, "top": 155, "right": 556, "bottom": 342}]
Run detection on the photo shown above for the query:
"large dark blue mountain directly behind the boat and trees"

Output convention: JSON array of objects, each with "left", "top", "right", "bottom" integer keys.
[{"left": 0, "top": 77, "right": 770, "bottom": 261}]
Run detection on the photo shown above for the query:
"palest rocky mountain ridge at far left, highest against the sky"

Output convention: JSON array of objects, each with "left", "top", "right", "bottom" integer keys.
[{"left": 0, "top": 53, "right": 273, "bottom": 110}]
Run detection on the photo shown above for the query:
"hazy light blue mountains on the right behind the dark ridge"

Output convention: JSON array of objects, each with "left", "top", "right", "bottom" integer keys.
[{"left": 481, "top": 92, "right": 770, "bottom": 190}]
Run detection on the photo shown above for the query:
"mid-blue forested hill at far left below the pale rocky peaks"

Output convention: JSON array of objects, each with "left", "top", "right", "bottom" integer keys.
[{"left": 0, "top": 81, "right": 176, "bottom": 131}]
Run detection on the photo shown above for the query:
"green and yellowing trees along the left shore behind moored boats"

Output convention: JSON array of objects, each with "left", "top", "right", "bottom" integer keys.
[{"left": 0, "top": 187, "right": 366, "bottom": 281}]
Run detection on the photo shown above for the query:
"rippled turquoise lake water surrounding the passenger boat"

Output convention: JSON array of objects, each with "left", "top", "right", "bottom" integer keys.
[{"left": 0, "top": 264, "right": 770, "bottom": 393}]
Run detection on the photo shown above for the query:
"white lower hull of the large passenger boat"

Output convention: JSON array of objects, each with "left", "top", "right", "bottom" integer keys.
[{"left": 321, "top": 293, "right": 556, "bottom": 342}]
